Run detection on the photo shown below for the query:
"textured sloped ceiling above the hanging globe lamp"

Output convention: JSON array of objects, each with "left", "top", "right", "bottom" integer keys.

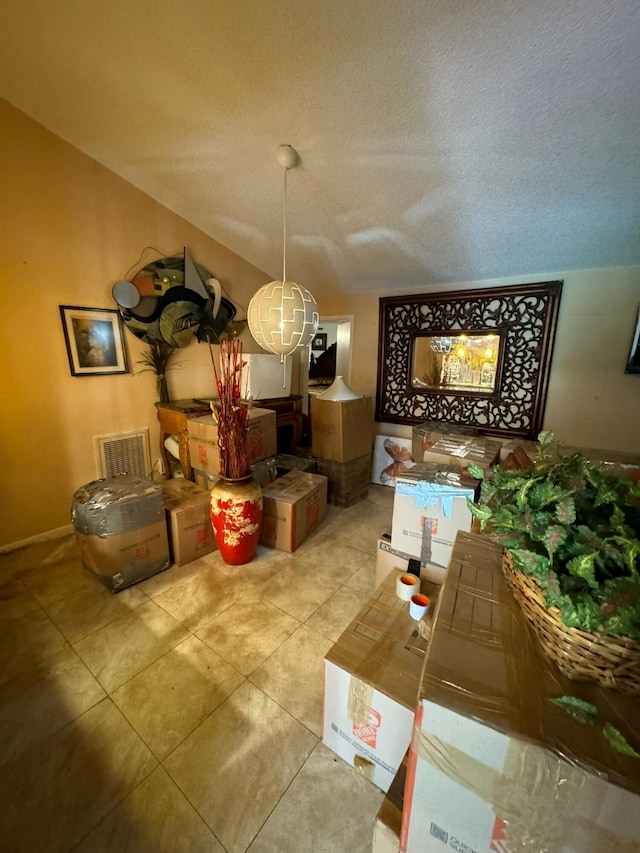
[{"left": 0, "top": 0, "right": 640, "bottom": 295}]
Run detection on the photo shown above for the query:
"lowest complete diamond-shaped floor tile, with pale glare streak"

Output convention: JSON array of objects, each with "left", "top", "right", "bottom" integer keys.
[{"left": 164, "top": 683, "right": 317, "bottom": 853}]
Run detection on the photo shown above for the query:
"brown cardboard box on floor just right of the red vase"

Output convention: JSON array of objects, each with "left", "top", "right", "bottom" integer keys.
[{"left": 260, "top": 471, "right": 327, "bottom": 552}]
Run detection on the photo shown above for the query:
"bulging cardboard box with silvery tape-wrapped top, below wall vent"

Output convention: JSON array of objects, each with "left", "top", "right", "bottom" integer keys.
[{"left": 71, "top": 474, "right": 170, "bottom": 592}]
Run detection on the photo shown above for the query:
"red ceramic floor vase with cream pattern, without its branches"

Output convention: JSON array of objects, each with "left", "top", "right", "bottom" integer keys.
[{"left": 209, "top": 476, "right": 263, "bottom": 566}]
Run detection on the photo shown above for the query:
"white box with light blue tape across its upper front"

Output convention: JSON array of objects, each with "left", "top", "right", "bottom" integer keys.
[{"left": 391, "top": 462, "right": 479, "bottom": 568}]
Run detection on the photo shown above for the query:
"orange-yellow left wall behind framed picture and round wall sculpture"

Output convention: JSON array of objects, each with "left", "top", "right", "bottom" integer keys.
[{"left": 0, "top": 100, "right": 270, "bottom": 546}]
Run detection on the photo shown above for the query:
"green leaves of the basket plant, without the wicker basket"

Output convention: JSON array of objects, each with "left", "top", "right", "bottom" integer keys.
[{"left": 468, "top": 432, "right": 640, "bottom": 640}]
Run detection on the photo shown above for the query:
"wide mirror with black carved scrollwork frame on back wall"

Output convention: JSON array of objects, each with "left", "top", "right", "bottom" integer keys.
[{"left": 376, "top": 281, "right": 562, "bottom": 439}]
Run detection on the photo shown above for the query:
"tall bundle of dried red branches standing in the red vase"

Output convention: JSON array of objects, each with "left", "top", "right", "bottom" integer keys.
[{"left": 209, "top": 339, "right": 251, "bottom": 479}]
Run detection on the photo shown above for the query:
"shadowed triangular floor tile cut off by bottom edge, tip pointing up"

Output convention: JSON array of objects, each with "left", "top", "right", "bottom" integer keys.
[{"left": 74, "top": 767, "right": 225, "bottom": 853}]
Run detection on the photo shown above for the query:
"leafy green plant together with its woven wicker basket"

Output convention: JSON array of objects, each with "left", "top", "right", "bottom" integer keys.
[{"left": 469, "top": 432, "right": 640, "bottom": 692}]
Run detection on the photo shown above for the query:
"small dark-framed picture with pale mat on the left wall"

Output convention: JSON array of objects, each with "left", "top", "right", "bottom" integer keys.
[{"left": 60, "top": 305, "right": 129, "bottom": 376}]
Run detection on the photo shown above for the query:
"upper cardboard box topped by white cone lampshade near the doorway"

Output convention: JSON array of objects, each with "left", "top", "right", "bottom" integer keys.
[{"left": 311, "top": 397, "right": 373, "bottom": 462}]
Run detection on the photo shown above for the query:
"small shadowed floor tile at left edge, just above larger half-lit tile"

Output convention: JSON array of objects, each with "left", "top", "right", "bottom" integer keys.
[{"left": 0, "top": 609, "right": 68, "bottom": 684}]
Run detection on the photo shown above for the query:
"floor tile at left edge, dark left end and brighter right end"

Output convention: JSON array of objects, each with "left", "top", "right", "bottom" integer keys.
[{"left": 0, "top": 648, "right": 105, "bottom": 765}]
